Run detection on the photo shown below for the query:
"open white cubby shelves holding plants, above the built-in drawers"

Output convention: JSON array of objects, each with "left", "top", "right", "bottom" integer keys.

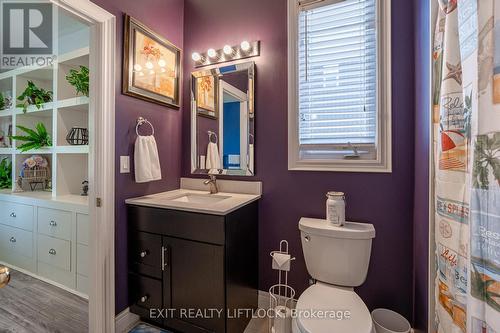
[{"left": 0, "top": 47, "right": 89, "bottom": 204}]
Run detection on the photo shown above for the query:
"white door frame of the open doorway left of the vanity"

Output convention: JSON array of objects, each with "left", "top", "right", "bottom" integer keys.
[{"left": 50, "top": 0, "right": 116, "bottom": 333}]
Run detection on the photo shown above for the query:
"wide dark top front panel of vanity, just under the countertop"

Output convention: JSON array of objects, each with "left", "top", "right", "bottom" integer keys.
[{"left": 127, "top": 205, "right": 225, "bottom": 245}]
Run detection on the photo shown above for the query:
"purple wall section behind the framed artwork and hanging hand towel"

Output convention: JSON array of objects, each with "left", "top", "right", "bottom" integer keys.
[{"left": 92, "top": 0, "right": 184, "bottom": 313}]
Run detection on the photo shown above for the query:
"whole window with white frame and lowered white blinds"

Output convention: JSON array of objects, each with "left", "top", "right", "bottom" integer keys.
[{"left": 288, "top": 0, "right": 391, "bottom": 172}]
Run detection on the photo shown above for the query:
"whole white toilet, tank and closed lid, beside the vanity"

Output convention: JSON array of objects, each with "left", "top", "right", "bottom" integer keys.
[{"left": 292, "top": 218, "right": 375, "bottom": 333}]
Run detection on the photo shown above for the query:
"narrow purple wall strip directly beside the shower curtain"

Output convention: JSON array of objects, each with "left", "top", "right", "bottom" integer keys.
[{"left": 413, "top": 0, "right": 431, "bottom": 332}]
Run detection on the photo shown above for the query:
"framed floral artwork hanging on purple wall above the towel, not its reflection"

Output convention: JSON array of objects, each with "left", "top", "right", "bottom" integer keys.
[{"left": 122, "top": 15, "right": 181, "bottom": 108}]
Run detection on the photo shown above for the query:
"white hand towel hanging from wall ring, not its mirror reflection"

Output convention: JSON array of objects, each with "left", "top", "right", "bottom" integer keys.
[{"left": 134, "top": 135, "right": 161, "bottom": 183}]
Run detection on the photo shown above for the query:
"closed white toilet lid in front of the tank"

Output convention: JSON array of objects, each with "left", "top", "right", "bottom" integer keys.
[{"left": 296, "top": 283, "right": 372, "bottom": 333}]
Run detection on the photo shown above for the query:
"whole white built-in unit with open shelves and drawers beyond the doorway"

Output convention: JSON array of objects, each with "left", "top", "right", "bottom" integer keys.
[{"left": 0, "top": 6, "right": 92, "bottom": 297}]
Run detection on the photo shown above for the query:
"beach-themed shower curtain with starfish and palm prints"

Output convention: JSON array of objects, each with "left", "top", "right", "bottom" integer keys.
[{"left": 430, "top": 0, "right": 500, "bottom": 333}]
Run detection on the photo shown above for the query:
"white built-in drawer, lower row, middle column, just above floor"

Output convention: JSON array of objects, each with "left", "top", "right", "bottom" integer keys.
[{"left": 38, "top": 235, "right": 71, "bottom": 271}]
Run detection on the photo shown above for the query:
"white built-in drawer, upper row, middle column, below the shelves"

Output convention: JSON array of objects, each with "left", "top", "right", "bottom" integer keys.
[{"left": 38, "top": 207, "right": 71, "bottom": 240}]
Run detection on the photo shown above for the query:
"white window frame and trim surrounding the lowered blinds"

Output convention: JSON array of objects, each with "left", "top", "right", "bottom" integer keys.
[{"left": 288, "top": 0, "right": 392, "bottom": 173}]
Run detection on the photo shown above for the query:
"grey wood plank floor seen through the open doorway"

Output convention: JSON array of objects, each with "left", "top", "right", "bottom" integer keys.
[{"left": 0, "top": 270, "right": 88, "bottom": 333}]
